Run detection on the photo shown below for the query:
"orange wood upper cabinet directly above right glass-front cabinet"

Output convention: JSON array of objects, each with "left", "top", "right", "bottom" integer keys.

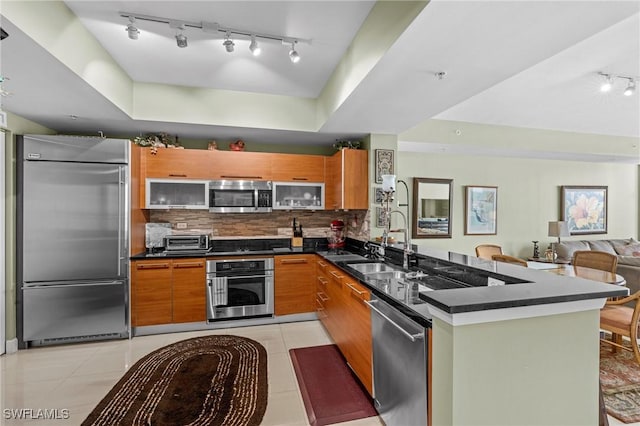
[{"left": 271, "top": 154, "right": 325, "bottom": 182}]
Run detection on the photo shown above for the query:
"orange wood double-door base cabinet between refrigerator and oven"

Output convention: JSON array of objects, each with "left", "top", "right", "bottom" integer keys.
[{"left": 131, "top": 259, "right": 207, "bottom": 327}]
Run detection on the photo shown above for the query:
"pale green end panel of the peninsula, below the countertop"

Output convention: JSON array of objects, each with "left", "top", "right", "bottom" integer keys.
[{"left": 432, "top": 310, "right": 600, "bottom": 426}]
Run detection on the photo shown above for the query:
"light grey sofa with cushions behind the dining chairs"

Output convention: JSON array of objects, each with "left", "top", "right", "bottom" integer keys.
[{"left": 555, "top": 238, "right": 640, "bottom": 294}]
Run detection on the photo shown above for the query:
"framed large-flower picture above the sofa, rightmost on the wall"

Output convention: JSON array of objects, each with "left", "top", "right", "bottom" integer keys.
[{"left": 561, "top": 186, "right": 608, "bottom": 235}]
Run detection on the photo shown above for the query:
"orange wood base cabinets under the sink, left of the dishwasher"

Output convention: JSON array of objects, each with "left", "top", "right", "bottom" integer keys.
[{"left": 316, "top": 258, "right": 373, "bottom": 394}]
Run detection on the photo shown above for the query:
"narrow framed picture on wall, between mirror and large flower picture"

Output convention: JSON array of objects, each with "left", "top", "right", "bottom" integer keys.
[{"left": 464, "top": 186, "right": 498, "bottom": 235}]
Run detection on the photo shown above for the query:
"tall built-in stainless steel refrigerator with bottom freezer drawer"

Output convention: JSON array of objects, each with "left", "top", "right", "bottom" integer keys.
[{"left": 16, "top": 135, "right": 129, "bottom": 348}]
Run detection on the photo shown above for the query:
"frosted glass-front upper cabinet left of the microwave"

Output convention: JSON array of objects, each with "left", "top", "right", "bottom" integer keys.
[{"left": 145, "top": 179, "right": 209, "bottom": 210}]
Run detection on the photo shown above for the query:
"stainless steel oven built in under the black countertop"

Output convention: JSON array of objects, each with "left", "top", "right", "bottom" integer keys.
[{"left": 207, "top": 258, "right": 274, "bottom": 321}]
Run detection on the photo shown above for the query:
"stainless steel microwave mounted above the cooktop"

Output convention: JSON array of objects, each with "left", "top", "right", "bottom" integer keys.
[{"left": 209, "top": 180, "right": 272, "bottom": 213}]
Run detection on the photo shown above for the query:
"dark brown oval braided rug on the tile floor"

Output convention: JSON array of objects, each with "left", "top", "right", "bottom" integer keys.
[{"left": 82, "top": 335, "right": 268, "bottom": 426}]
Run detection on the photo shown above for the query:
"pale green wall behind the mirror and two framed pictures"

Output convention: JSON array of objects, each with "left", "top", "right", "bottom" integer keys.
[{"left": 397, "top": 152, "right": 638, "bottom": 258}]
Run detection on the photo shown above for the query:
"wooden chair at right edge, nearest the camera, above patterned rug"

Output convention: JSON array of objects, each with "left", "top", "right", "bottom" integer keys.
[{"left": 600, "top": 291, "right": 640, "bottom": 364}]
